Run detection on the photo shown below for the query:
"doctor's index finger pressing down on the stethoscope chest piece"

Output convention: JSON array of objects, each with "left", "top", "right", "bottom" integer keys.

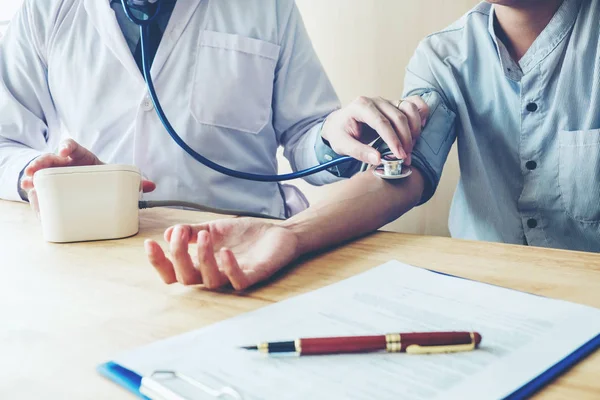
[{"left": 350, "top": 97, "right": 406, "bottom": 158}]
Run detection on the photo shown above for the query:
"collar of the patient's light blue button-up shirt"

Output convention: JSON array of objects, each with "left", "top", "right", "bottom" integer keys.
[{"left": 488, "top": 0, "right": 581, "bottom": 80}]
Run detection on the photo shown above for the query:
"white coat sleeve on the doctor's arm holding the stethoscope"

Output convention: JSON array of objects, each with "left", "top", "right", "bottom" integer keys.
[{"left": 273, "top": 1, "right": 341, "bottom": 185}]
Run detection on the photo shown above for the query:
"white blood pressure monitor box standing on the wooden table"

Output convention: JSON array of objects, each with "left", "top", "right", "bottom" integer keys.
[{"left": 33, "top": 165, "right": 141, "bottom": 243}]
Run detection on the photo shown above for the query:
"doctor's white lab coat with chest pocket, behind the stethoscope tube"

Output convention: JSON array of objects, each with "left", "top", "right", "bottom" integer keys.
[{"left": 0, "top": 0, "right": 339, "bottom": 217}]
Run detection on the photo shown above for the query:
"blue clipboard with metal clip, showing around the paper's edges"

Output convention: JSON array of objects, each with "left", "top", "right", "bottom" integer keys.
[{"left": 97, "top": 262, "right": 600, "bottom": 400}]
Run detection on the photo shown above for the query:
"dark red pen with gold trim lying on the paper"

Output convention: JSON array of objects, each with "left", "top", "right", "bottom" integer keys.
[{"left": 242, "top": 332, "right": 481, "bottom": 356}]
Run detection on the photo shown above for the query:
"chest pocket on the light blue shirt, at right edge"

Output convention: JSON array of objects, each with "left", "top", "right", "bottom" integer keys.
[{"left": 558, "top": 129, "right": 600, "bottom": 223}]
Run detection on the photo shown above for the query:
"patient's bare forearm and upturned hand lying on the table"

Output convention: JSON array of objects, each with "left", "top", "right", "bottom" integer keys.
[{"left": 145, "top": 169, "right": 424, "bottom": 290}]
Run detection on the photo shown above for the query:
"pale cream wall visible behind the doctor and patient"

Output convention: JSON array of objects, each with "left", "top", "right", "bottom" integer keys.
[{"left": 0, "top": 0, "right": 478, "bottom": 236}]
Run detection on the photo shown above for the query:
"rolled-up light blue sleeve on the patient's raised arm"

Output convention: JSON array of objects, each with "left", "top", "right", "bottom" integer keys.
[{"left": 402, "top": 39, "right": 456, "bottom": 204}]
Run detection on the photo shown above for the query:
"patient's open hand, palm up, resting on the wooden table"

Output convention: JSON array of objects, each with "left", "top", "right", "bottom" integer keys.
[{"left": 145, "top": 218, "right": 298, "bottom": 290}]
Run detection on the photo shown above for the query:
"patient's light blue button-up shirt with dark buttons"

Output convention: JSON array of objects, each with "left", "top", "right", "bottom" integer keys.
[{"left": 404, "top": 0, "right": 600, "bottom": 251}]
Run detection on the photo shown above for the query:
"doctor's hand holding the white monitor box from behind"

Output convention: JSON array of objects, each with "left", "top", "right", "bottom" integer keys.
[{"left": 20, "top": 139, "right": 156, "bottom": 214}]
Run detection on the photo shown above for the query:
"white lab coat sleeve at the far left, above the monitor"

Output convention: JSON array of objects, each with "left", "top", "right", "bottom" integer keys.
[{"left": 0, "top": 0, "right": 57, "bottom": 201}]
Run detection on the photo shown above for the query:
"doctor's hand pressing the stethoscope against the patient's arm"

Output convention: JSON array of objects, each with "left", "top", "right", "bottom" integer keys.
[{"left": 321, "top": 96, "right": 429, "bottom": 165}]
